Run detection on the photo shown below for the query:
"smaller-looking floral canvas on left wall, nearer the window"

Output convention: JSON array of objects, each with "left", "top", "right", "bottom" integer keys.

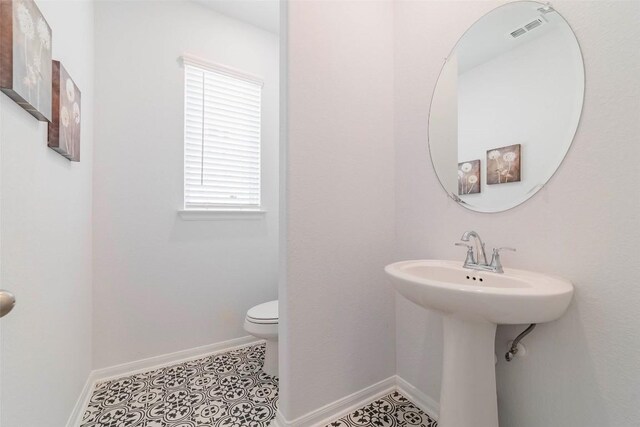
[{"left": 48, "top": 61, "right": 81, "bottom": 162}]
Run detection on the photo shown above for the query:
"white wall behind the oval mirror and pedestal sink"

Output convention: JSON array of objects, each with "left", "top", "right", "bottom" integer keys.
[{"left": 395, "top": 0, "right": 640, "bottom": 427}]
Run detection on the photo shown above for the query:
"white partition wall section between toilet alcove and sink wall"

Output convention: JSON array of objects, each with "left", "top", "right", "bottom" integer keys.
[{"left": 280, "top": 1, "right": 395, "bottom": 421}]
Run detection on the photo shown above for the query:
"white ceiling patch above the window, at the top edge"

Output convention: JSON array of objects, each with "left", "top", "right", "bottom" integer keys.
[{"left": 194, "top": 0, "right": 280, "bottom": 34}]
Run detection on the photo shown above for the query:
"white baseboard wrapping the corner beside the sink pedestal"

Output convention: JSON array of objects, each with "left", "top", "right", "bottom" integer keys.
[{"left": 270, "top": 375, "right": 440, "bottom": 427}]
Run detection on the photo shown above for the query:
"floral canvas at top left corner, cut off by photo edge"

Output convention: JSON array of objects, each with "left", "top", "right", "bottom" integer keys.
[{"left": 0, "top": 0, "right": 52, "bottom": 121}]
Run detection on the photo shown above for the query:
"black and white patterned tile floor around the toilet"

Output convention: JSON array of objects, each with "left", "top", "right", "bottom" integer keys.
[{"left": 81, "top": 345, "right": 278, "bottom": 427}]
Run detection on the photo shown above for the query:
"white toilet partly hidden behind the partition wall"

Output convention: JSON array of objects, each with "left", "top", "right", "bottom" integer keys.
[{"left": 244, "top": 300, "right": 278, "bottom": 377}]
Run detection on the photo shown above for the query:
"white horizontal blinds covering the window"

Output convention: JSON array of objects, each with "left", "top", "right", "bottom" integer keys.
[{"left": 184, "top": 58, "right": 262, "bottom": 210}]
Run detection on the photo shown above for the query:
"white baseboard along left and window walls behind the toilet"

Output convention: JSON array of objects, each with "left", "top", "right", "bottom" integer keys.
[{"left": 67, "top": 336, "right": 263, "bottom": 427}]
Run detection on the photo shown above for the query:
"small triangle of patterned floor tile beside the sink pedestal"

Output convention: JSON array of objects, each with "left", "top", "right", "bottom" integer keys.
[{"left": 326, "top": 391, "right": 437, "bottom": 427}]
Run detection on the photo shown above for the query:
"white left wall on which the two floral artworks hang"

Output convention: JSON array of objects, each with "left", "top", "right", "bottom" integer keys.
[{"left": 0, "top": 1, "right": 94, "bottom": 427}]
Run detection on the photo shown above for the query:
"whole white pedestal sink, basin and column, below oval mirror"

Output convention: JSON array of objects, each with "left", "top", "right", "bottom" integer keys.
[{"left": 385, "top": 260, "right": 573, "bottom": 427}]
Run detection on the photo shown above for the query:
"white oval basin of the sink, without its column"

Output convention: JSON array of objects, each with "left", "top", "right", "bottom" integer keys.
[{"left": 385, "top": 260, "right": 573, "bottom": 324}]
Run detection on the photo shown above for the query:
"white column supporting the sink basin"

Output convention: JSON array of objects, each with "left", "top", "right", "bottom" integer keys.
[{"left": 438, "top": 315, "right": 498, "bottom": 427}]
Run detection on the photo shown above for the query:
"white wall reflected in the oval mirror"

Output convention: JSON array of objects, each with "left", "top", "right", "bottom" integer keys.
[{"left": 458, "top": 24, "right": 584, "bottom": 211}]
